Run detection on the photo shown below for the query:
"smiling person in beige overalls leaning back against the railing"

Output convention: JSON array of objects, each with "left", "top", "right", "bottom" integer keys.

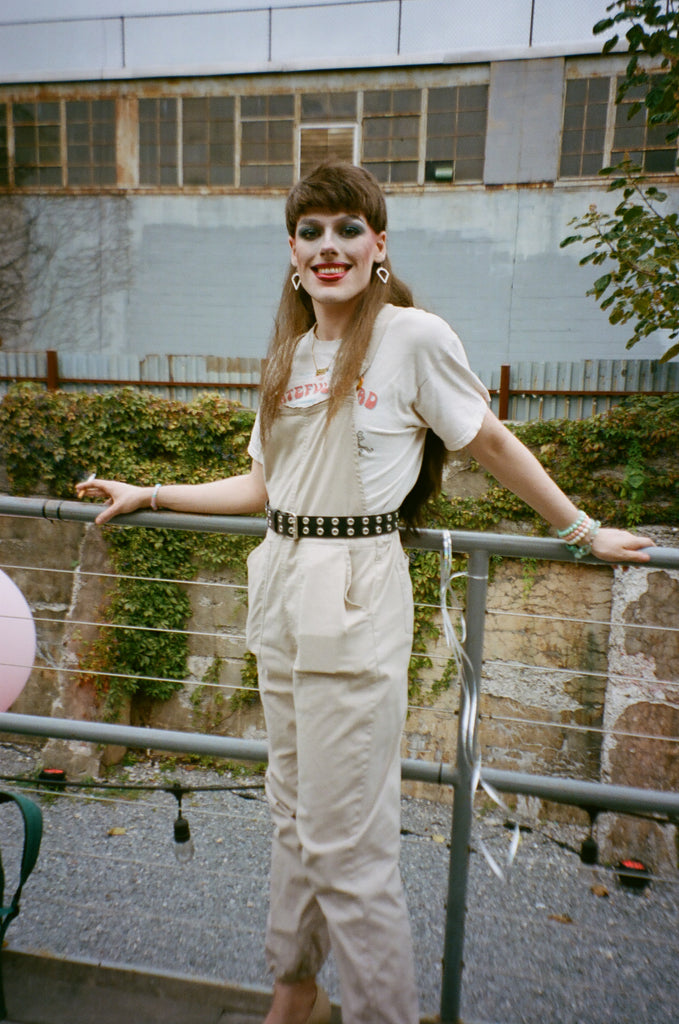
[{"left": 79, "top": 164, "right": 652, "bottom": 1024}]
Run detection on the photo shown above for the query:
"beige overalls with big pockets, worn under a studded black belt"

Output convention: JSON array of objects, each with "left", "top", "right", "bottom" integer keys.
[{"left": 248, "top": 315, "right": 419, "bottom": 1024}]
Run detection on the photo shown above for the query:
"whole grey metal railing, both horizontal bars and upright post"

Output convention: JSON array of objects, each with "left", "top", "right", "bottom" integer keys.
[{"left": 0, "top": 496, "right": 679, "bottom": 1024}]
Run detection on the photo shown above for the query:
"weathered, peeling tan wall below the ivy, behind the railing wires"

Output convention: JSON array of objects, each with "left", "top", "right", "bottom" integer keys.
[{"left": 0, "top": 507, "right": 679, "bottom": 870}]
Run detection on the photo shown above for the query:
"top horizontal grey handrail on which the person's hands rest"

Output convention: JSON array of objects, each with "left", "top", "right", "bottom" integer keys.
[{"left": 0, "top": 495, "right": 679, "bottom": 568}]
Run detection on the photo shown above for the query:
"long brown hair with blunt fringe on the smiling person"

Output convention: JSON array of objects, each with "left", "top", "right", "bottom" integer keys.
[{"left": 259, "top": 161, "right": 445, "bottom": 527}]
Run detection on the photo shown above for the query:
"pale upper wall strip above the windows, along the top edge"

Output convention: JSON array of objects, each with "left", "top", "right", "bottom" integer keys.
[{"left": 0, "top": 0, "right": 606, "bottom": 82}]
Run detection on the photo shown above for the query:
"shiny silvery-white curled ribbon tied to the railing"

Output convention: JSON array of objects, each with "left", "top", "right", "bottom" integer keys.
[{"left": 439, "top": 530, "right": 521, "bottom": 882}]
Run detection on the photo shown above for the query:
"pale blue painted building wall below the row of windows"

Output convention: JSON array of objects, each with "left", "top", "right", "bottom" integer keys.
[{"left": 9, "top": 180, "right": 675, "bottom": 380}]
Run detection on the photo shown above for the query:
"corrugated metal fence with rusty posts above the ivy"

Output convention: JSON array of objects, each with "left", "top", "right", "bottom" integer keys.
[{"left": 0, "top": 350, "right": 679, "bottom": 422}]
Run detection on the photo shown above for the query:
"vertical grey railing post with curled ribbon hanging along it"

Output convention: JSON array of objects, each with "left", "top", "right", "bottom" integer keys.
[{"left": 440, "top": 551, "right": 490, "bottom": 1024}]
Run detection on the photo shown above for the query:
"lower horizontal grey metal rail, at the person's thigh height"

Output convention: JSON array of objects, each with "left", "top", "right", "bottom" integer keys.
[{"left": 0, "top": 713, "right": 679, "bottom": 817}]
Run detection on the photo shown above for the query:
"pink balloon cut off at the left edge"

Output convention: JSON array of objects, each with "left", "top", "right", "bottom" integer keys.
[{"left": 0, "top": 570, "right": 36, "bottom": 712}]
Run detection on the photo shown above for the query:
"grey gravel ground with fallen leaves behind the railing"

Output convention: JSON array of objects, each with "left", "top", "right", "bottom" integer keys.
[{"left": 0, "top": 743, "right": 679, "bottom": 1024}]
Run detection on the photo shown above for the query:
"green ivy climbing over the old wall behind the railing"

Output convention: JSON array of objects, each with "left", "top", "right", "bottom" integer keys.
[{"left": 0, "top": 385, "right": 679, "bottom": 717}]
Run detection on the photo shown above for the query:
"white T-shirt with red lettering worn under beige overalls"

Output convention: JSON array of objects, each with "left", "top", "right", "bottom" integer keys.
[{"left": 248, "top": 307, "right": 490, "bottom": 514}]
